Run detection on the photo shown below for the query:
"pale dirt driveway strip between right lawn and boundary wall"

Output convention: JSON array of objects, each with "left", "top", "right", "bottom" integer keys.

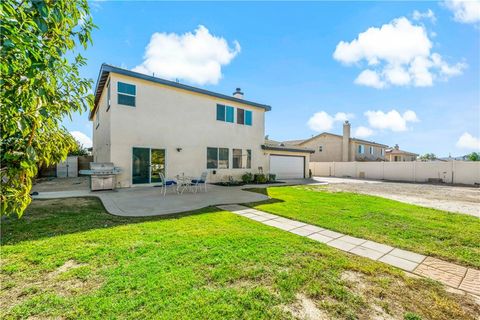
[{"left": 314, "top": 177, "right": 480, "bottom": 217}]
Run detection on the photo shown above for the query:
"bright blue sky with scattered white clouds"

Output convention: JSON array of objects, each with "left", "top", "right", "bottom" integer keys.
[{"left": 63, "top": 0, "right": 480, "bottom": 156}]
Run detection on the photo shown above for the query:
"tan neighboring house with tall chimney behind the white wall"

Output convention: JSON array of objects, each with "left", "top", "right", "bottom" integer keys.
[{"left": 282, "top": 121, "right": 388, "bottom": 162}]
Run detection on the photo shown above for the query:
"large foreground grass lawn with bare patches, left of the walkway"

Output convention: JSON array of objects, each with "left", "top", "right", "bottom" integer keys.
[{"left": 0, "top": 198, "right": 480, "bottom": 319}]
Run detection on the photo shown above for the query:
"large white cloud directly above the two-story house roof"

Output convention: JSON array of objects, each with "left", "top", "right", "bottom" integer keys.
[{"left": 133, "top": 25, "right": 240, "bottom": 85}]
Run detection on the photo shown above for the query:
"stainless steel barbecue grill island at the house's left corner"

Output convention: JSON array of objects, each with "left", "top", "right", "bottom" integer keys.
[{"left": 79, "top": 162, "right": 120, "bottom": 191}]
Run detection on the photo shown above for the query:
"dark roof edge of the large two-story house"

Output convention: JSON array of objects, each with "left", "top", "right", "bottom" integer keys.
[{"left": 89, "top": 63, "right": 272, "bottom": 120}]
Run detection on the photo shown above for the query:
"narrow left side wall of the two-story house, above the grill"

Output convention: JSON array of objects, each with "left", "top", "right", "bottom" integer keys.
[{"left": 92, "top": 77, "right": 113, "bottom": 162}]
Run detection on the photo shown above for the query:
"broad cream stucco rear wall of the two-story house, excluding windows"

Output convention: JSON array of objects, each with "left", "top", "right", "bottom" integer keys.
[{"left": 106, "top": 73, "right": 268, "bottom": 187}]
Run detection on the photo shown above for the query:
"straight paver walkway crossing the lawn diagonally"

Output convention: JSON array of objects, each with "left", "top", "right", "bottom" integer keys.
[{"left": 217, "top": 204, "right": 480, "bottom": 296}]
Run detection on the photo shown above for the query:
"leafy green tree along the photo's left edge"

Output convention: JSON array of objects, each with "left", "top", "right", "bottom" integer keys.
[{"left": 0, "top": 0, "right": 95, "bottom": 216}]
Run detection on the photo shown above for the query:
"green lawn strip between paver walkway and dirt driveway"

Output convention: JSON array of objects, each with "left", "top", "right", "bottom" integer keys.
[{"left": 246, "top": 186, "right": 480, "bottom": 268}]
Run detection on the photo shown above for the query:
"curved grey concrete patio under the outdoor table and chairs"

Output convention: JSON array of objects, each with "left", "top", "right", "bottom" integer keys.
[{"left": 32, "top": 179, "right": 318, "bottom": 217}]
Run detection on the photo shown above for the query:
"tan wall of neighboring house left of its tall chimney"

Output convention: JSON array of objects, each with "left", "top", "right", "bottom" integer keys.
[{"left": 301, "top": 135, "right": 342, "bottom": 162}]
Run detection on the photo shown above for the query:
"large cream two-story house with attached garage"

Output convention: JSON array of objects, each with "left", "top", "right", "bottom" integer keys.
[{"left": 89, "top": 64, "right": 310, "bottom": 187}]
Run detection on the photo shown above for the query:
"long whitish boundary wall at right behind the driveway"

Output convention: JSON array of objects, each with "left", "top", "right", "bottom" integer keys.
[{"left": 310, "top": 161, "right": 480, "bottom": 184}]
